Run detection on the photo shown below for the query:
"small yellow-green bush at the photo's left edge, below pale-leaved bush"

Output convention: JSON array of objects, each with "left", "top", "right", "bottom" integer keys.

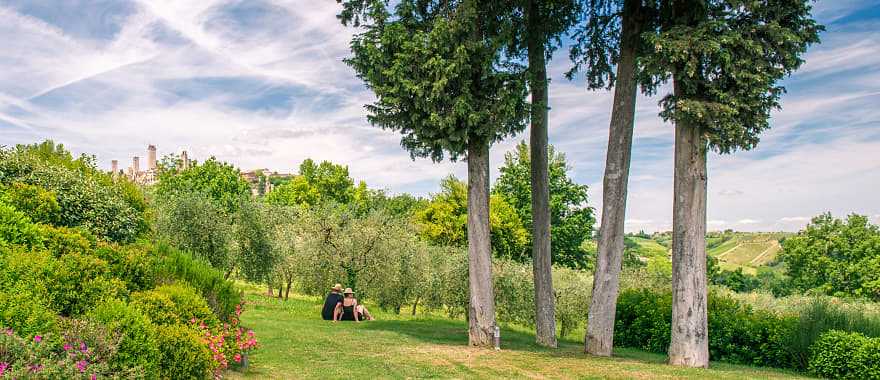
[{"left": 0, "top": 182, "right": 61, "bottom": 224}]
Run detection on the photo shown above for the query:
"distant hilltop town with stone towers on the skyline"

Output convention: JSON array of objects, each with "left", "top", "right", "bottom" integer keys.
[{"left": 110, "top": 144, "right": 293, "bottom": 195}]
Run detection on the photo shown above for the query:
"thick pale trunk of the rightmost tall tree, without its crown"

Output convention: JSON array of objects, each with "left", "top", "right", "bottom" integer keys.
[{"left": 669, "top": 78, "right": 709, "bottom": 367}]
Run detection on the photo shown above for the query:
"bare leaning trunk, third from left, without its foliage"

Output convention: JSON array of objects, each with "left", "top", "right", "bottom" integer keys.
[{"left": 584, "top": 0, "right": 639, "bottom": 356}]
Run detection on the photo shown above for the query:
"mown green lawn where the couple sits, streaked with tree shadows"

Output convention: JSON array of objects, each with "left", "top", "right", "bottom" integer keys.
[{"left": 227, "top": 288, "right": 812, "bottom": 379}]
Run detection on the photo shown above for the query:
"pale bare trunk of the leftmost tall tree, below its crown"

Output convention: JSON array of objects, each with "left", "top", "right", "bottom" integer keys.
[{"left": 467, "top": 137, "right": 495, "bottom": 347}]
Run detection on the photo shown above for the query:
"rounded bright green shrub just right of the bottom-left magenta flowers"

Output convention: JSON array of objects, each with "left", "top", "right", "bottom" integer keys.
[{"left": 88, "top": 301, "right": 161, "bottom": 378}]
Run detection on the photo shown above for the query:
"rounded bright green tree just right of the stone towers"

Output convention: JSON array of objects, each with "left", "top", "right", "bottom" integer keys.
[{"left": 155, "top": 157, "right": 251, "bottom": 213}]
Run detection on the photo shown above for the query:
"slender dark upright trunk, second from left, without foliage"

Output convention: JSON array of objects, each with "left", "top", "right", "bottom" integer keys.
[{"left": 527, "top": 0, "right": 557, "bottom": 348}]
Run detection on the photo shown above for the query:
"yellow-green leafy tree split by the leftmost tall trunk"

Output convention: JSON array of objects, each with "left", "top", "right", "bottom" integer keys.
[{"left": 415, "top": 176, "right": 531, "bottom": 261}]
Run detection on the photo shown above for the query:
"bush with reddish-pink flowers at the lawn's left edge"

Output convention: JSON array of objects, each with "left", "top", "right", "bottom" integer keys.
[{"left": 190, "top": 302, "right": 258, "bottom": 378}]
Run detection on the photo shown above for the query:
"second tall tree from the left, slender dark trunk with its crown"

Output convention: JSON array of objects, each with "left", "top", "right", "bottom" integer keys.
[{"left": 500, "top": 0, "right": 580, "bottom": 347}]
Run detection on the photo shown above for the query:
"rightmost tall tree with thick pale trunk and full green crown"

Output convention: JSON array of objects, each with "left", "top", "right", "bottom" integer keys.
[{"left": 643, "top": 0, "right": 822, "bottom": 367}]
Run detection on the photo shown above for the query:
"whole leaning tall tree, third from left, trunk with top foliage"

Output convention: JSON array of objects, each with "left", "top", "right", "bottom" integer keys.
[{"left": 568, "top": 0, "right": 655, "bottom": 356}]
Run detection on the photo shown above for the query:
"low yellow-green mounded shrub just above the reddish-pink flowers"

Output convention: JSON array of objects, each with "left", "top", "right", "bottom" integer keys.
[{"left": 131, "top": 284, "right": 218, "bottom": 326}]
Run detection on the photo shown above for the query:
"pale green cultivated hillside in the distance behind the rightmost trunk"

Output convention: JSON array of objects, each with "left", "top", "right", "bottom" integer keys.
[{"left": 627, "top": 231, "right": 788, "bottom": 274}]
